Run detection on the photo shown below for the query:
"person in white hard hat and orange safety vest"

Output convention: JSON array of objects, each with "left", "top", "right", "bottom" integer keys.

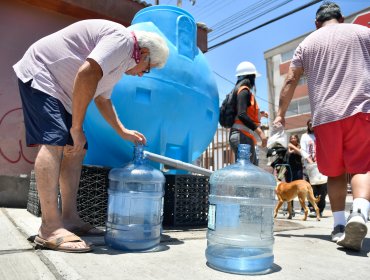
[{"left": 229, "top": 61, "right": 267, "bottom": 165}]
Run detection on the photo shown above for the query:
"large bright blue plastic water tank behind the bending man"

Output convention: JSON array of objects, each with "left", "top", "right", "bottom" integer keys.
[{"left": 84, "top": 5, "right": 219, "bottom": 170}]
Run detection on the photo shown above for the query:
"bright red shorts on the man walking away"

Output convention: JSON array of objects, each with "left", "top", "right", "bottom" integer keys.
[{"left": 315, "top": 113, "right": 370, "bottom": 177}]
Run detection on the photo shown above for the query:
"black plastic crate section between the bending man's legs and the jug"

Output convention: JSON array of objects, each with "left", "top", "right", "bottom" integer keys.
[{"left": 77, "top": 165, "right": 110, "bottom": 227}]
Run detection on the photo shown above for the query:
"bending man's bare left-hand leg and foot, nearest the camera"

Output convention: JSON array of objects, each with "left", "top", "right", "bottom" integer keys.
[{"left": 35, "top": 145, "right": 86, "bottom": 248}]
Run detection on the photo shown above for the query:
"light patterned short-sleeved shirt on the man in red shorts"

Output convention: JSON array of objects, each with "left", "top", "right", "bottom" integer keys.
[{"left": 290, "top": 23, "right": 370, "bottom": 126}]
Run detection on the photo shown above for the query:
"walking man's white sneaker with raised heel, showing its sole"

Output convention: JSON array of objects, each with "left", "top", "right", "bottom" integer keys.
[{"left": 337, "top": 209, "right": 367, "bottom": 251}]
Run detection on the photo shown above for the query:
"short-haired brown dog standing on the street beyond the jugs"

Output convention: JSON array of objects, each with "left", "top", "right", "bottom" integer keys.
[{"left": 274, "top": 180, "right": 320, "bottom": 221}]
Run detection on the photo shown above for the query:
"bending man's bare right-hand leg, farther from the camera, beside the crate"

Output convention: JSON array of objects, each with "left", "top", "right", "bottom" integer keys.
[{"left": 59, "top": 146, "right": 103, "bottom": 235}]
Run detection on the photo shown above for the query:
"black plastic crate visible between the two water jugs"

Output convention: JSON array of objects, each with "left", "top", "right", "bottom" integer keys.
[{"left": 163, "top": 175, "right": 209, "bottom": 227}]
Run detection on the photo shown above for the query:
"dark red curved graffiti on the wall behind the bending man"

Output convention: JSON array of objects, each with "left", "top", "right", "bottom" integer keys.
[{"left": 0, "top": 108, "right": 36, "bottom": 164}]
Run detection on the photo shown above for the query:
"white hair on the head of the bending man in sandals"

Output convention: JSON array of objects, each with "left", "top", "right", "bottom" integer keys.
[{"left": 134, "top": 30, "right": 170, "bottom": 68}]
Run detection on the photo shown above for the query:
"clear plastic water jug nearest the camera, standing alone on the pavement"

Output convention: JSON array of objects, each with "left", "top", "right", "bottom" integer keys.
[{"left": 206, "top": 144, "right": 276, "bottom": 274}]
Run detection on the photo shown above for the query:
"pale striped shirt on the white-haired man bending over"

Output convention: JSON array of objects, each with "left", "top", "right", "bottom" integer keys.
[{"left": 13, "top": 19, "right": 136, "bottom": 113}]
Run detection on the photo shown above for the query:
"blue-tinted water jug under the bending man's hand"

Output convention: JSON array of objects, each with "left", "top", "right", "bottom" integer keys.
[{"left": 105, "top": 145, "right": 165, "bottom": 251}]
